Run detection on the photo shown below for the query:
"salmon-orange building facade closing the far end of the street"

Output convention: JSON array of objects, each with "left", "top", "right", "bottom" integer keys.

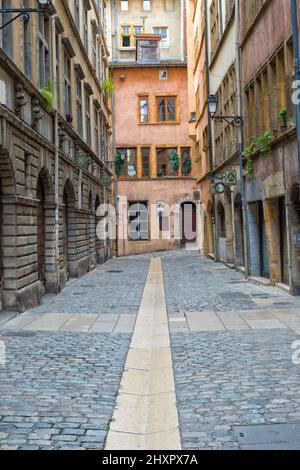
[{"left": 110, "top": 0, "right": 201, "bottom": 255}]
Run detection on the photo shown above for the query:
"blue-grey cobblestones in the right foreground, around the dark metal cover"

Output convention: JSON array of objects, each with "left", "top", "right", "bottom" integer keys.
[{"left": 171, "top": 330, "right": 300, "bottom": 450}]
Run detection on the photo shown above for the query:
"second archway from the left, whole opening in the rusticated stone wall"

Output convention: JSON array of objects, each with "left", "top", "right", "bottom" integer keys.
[{"left": 36, "top": 168, "right": 57, "bottom": 292}]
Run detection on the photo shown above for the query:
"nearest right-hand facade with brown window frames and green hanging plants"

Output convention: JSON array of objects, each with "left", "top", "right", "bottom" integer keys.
[{"left": 241, "top": 0, "right": 300, "bottom": 294}]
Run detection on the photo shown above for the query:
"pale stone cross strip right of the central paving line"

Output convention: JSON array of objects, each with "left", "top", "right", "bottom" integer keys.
[{"left": 169, "top": 308, "right": 300, "bottom": 334}]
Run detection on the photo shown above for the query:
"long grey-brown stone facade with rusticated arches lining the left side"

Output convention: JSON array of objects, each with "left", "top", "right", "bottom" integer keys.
[{"left": 0, "top": 0, "right": 112, "bottom": 311}]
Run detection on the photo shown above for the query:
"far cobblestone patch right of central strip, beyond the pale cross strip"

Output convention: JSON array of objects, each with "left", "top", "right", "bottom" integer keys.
[{"left": 161, "top": 250, "right": 300, "bottom": 314}]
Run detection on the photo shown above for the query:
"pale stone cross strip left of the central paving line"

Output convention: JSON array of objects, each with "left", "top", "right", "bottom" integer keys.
[{"left": 0, "top": 312, "right": 136, "bottom": 333}]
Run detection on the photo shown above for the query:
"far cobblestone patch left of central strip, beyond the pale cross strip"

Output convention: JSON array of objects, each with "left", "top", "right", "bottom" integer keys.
[{"left": 32, "top": 256, "right": 150, "bottom": 314}]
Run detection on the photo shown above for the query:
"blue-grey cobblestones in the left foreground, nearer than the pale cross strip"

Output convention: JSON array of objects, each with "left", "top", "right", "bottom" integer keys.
[{"left": 0, "top": 332, "right": 131, "bottom": 450}]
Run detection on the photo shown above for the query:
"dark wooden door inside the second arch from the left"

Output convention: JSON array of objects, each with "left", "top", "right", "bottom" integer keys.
[{"left": 37, "top": 179, "right": 45, "bottom": 285}]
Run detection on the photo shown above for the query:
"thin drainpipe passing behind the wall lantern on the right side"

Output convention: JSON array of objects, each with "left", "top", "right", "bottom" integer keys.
[{"left": 204, "top": 0, "right": 218, "bottom": 263}]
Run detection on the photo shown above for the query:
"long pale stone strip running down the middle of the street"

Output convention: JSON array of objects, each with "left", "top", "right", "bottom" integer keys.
[{"left": 106, "top": 258, "right": 181, "bottom": 450}]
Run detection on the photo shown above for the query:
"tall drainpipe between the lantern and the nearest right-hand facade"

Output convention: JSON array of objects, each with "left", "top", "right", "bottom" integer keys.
[{"left": 235, "top": 0, "right": 251, "bottom": 278}]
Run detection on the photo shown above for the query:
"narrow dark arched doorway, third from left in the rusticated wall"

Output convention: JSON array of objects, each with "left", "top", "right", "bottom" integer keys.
[{"left": 63, "top": 180, "right": 76, "bottom": 280}]
